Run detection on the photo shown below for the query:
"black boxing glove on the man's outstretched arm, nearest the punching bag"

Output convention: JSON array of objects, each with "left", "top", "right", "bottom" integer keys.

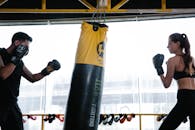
[{"left": 41, "top": 60, "right": 61, "bottom": 76}]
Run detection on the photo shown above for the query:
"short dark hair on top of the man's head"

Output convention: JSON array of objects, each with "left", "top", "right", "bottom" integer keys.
[{"left": 12, "top": 32, "right": 32, "bottom": 43}]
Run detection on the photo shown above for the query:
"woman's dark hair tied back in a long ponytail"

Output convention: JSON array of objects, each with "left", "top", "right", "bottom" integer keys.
[{"left": 169, "top": 33, "right": 194, "bottom": 69}]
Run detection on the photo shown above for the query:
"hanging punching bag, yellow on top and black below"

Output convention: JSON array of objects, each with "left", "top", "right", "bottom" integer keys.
[{"left": 63, "top": 22, "right": 108, "bottom": 130}]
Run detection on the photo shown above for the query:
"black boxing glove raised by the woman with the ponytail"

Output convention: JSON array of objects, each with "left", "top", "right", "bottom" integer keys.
[{"left": 153, "top": 54, "right": 164, "bottom": 75}]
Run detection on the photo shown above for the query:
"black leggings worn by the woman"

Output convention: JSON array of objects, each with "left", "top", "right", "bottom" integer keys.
[{"left": 159, "top": 89, "right": 195, "bottom": 130}]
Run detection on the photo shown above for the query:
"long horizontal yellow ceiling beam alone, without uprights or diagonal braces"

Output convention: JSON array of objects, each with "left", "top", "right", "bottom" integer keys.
[{"left": 0, "top": 8, "right": 195, "bottom": 14}]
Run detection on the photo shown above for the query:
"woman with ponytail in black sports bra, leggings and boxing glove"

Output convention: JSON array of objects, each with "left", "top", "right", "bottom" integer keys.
[{"left": 153, "top": 33, "right": 195, "bottom": 130}]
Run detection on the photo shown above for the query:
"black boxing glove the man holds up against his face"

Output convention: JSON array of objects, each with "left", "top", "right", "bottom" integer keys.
[{"left": 11, "top": 44, "right": 28, "bottom": 65}]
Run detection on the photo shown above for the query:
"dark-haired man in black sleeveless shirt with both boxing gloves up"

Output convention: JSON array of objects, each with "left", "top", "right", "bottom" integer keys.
[{"left": 0, "top": 32, "right": 60, "bottom": 130}]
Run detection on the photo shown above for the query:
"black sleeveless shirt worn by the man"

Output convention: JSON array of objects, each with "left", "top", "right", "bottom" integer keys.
[{"left": 0, "top": 48, "right": 24, "bottom": 106}]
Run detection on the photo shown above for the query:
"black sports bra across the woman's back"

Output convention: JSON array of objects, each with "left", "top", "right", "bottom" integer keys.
[{"left": 173, "top": 71, "right": 195, "bottom": 80}]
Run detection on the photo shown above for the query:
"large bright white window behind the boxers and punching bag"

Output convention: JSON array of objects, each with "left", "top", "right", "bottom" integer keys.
[{"left": 0, "top": 18, "right": 195, "bottom": 130}]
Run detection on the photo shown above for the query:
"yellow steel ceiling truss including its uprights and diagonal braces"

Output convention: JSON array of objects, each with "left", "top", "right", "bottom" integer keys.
[{"left": 0, "top": 0, "right": 195, "bottom": 14}]
